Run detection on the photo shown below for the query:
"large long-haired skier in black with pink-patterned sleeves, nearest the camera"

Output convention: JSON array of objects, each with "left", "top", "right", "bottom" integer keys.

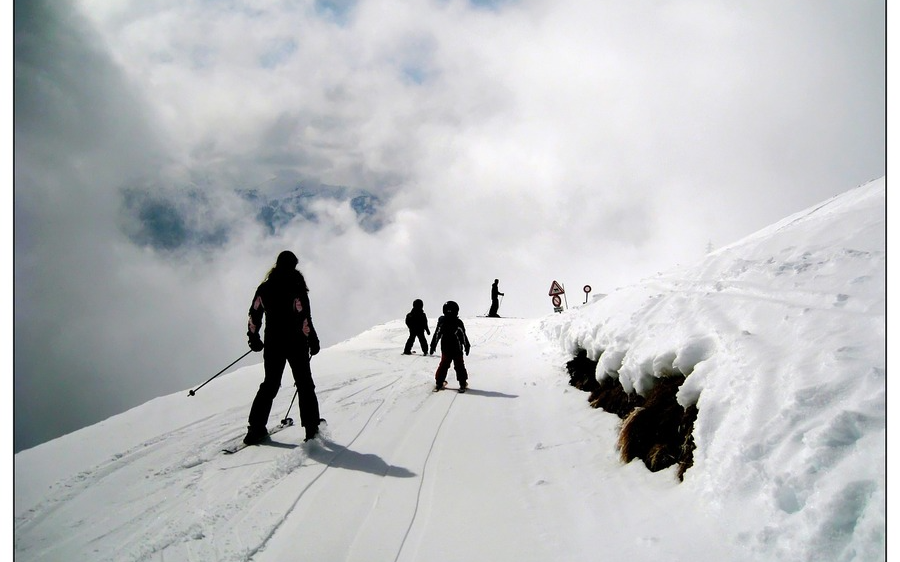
[{"left": 244, "top": 250, "right": 320, "bottom": 445}]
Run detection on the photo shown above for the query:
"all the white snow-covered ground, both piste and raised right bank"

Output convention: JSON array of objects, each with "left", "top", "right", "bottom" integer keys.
[{"left": 14, "top": 179, "right": 886, "bottom": 562}]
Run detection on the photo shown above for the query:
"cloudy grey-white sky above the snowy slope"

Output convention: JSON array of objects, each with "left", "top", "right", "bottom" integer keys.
[{"left": 14, "top": 0, "right": 886, "bottom": 451}]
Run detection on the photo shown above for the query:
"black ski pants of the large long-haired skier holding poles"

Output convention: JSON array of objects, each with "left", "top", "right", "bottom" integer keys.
[{"left": 248, "top": 345, "right": 319, "bottom": 430}]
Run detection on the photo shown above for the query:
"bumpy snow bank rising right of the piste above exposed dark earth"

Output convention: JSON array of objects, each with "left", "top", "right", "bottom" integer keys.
[{"left": 544, "top": 179, "right": 886, "bottom": 560}]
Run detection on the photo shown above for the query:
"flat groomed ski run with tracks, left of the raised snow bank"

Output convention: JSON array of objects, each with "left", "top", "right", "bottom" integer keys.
[{"left": 15, "top": 319, "right": 756, "bottom": 562}]
